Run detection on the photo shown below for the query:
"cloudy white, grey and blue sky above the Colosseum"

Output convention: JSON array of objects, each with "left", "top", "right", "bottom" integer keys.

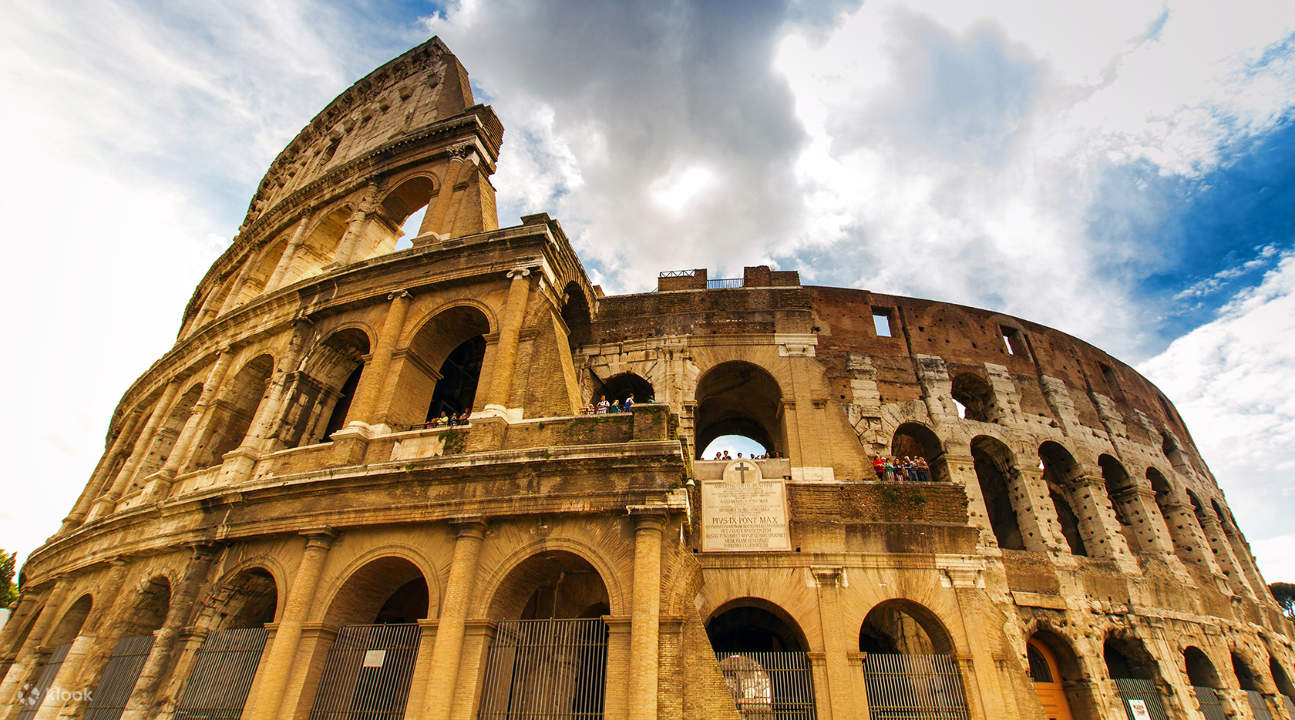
[{"left": 0, "top": 0, "right": 1295, "bottom": 581}]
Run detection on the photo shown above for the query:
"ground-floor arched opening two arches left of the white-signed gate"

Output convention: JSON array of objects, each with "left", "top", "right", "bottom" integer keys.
[{"left": 85, "top": 575, "right": 171, "bottom": 720}]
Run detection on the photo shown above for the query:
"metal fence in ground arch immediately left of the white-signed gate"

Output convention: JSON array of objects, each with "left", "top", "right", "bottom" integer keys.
[{"left": 175, "top": 628, "right": 269, "bottom": 720}]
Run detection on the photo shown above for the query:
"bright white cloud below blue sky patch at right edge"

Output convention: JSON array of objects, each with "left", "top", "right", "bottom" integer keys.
[{"left": 1141, "top": 253, "right": 1295, "bottom": 581}]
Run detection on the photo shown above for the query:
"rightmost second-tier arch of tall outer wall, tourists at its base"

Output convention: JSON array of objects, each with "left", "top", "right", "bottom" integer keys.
[{"left": 391, "top": 306, "right": 490, "bottom": 427}]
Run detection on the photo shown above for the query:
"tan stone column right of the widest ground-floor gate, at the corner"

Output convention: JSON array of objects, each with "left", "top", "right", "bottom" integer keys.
[{"left": 627, "top": 509, "right": 666, "bottom": 720}]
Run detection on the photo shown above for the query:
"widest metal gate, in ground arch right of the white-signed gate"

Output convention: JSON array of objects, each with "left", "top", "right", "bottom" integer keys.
[{"left": 477, "top": 618, "right": 607, "bottom": 720}]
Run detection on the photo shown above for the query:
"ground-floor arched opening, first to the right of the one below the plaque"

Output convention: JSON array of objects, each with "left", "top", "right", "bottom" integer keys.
[{"left": 859, "top": 600, "right": 967, "bottom": 717}]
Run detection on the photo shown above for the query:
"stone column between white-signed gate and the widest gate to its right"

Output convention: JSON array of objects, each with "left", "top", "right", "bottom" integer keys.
[{"left": 425, "top": 518, "right": 486, "bottom": 720}]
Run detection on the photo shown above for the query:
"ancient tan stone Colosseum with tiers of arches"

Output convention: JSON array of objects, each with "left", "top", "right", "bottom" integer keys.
[{"left": 0, "top": 39, "right": 1295, "bottom": 720}]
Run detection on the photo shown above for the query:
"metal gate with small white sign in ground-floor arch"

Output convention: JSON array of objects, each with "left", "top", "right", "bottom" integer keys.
[{"left": 310, "top": 623, "right": 421, "bottom": 720}]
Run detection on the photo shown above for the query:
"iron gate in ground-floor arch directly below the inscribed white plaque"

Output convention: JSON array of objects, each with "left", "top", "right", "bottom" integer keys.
[{"left": 715, "top": 651, "right": 816, "bottom": 720}]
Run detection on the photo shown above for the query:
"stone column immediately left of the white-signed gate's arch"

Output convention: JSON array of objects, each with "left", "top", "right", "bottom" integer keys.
[{"left": 243, "top": 530, "right": 334, "bottom": 720}]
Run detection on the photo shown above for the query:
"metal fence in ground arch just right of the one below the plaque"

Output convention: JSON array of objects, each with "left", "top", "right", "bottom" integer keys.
[{"left": 864, "top": 653, "right": 970, "bottom": 720}]
